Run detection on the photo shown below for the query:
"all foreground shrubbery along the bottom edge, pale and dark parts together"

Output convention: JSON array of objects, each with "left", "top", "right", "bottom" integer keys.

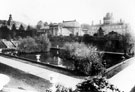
[{"left": 46, "top": 76, "right": 123, "bottom": 92}]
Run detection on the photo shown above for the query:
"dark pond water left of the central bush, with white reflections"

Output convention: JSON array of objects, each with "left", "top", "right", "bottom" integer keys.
[{"left": 19, "top": 50, "right": 74, "bottom": 70}]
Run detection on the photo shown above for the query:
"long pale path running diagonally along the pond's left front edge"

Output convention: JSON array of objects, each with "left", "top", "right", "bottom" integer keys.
[{"left": 0, "top": 56, "right": 82, "bottom": 89}]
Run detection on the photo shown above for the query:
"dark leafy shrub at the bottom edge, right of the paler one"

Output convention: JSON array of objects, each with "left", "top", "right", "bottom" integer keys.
[{"left": 76, "top": 77, "right": 122, "bottom": 92}]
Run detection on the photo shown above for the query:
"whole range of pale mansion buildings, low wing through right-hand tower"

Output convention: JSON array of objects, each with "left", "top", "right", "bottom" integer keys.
[{"left": 38, "top": 13, "right": 129, "bottom": 36}]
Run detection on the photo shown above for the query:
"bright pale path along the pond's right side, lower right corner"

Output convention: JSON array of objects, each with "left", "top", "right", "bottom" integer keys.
[{"left": 109, "top": 57, "right": 135, "bottom": 92}]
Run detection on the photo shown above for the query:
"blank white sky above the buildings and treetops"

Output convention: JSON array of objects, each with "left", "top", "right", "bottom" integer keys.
[{"left": 0, "top": 0, "right": 135, "bottom": 32}]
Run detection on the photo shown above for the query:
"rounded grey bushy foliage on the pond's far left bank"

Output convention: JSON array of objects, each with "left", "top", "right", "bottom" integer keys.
[{"left": 18, "top": 35, "right": 51, "bottom": 53}]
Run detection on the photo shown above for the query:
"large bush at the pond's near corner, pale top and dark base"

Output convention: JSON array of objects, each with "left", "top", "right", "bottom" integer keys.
[{"left": 62, "top": 42, "right": 105, "bottom": 75}]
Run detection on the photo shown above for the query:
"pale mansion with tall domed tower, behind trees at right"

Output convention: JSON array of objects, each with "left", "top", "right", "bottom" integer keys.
[{"left": 85, "top": 13, "right": 129, "bottom": 36}]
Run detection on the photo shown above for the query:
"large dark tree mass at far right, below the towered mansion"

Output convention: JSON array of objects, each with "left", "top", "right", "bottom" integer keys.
[{"left": 105, "top": 31, "right": 134, "bottom": 54}]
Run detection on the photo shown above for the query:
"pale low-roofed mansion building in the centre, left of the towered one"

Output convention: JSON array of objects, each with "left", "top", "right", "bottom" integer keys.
[{"left": 38, "top": 20, "right": 83, "bottom": 36}]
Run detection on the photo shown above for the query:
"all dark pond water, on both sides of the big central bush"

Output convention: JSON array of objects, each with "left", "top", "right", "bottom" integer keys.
[{"left": 12, "top": 50, "right": 122, "bottom": 70}]
